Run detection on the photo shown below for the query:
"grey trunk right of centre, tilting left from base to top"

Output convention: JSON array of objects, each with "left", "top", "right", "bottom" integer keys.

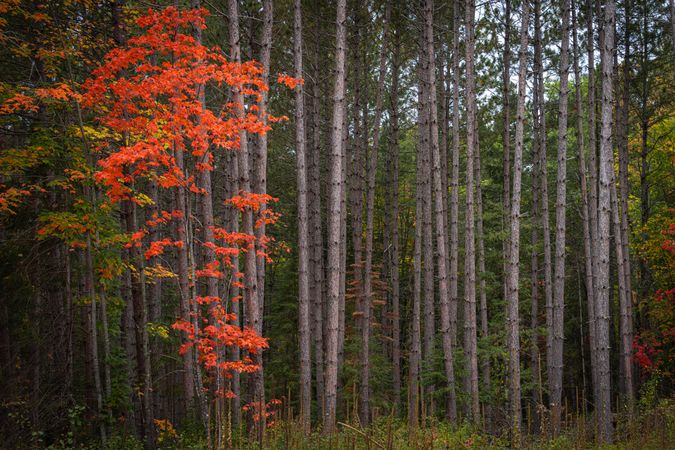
[{"left": 424, "top": 0, "right": 457, "bottom": 422}]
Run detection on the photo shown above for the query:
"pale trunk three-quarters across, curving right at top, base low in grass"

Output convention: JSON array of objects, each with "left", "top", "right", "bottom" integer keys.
[{"left": 507, "top": 2, "right": 529, "bottom": 442}]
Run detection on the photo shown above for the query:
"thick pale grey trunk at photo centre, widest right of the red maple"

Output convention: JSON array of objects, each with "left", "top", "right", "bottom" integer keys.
[{"left": 323, "top": 0, "right": 346, "bottom": 433}]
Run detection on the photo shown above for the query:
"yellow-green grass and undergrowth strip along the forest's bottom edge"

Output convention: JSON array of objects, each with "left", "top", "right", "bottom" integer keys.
[{"left": 125, "top": 400, "right": 675, "bottom": 450}]
